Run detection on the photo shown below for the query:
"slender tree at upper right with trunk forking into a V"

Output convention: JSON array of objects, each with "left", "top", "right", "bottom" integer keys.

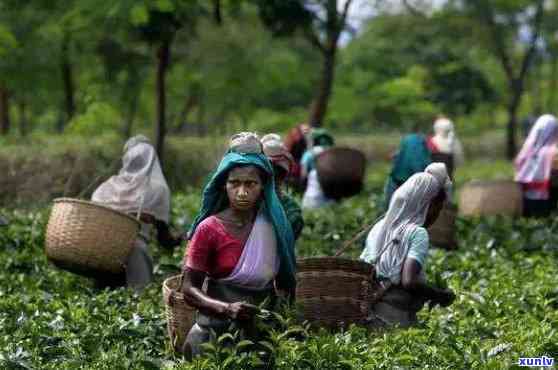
[{"left": 463, "top": 0, "right": 545, "bottom": 159}]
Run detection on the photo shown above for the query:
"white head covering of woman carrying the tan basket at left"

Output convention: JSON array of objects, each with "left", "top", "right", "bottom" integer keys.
[{"left": 91, "top": 135, "right": 170, "bottom": 223}]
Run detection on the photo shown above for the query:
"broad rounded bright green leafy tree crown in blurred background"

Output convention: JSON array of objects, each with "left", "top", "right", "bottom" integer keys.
[{"left": 332, "top": 8, "right": 495, "bottom": 127}]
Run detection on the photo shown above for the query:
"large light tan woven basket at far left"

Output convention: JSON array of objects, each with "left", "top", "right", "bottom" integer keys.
[{"left": 45, "top": 198, "right": 140, "bottom": 276}]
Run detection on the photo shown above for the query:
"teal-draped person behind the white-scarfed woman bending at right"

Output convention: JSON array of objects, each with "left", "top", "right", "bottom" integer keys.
[{"left": 384, "top": 134, "right": 432, "bottom": 209}]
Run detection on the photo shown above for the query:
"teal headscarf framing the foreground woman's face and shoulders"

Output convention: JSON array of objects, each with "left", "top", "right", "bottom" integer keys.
[{"left": 189, "top": 152, "right": 296, "bottom": 288}]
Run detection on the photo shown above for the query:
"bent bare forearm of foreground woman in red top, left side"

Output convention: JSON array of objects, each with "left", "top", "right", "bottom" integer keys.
[{"left": 181, "top": 267, "right": 258, "bottom": 320}]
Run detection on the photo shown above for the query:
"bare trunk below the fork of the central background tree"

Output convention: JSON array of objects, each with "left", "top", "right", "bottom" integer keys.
[{"left": 308, "top": 47, "right": 336, "bottom": 127}]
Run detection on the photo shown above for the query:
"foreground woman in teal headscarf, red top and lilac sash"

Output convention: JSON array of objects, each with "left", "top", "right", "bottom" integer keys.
[{"left": 182, "top": 133, "right": 296, "bottom": 355}]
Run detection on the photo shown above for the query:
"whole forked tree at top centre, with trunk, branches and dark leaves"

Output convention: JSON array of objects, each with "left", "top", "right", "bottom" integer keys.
[{"left": 258, "top": 0, "right": 352, "bottom": 127}]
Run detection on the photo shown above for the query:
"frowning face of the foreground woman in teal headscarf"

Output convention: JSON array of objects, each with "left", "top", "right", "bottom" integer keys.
[{"left": 225, "top": 166, "right": 263, "bottom": 211}]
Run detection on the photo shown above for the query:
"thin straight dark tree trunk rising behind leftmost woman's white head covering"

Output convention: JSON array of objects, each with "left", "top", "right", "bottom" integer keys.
[{"left": 155, "top": 39, "right": 171, "bottom": 162}]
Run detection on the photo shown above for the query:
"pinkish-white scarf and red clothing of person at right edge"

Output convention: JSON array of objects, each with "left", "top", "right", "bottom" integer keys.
[{"left": 515, "top": 114, "right": 558, "bottom": 199}]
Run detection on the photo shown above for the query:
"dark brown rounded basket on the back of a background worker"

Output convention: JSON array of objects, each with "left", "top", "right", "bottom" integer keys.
[{"left": 316, "top": 147, "right": 366, "bottom": 199}]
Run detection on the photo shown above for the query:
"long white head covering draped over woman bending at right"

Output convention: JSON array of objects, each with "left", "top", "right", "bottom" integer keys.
[{"left": 373, "top": 168, "right": 451, "bottom": 284}]
